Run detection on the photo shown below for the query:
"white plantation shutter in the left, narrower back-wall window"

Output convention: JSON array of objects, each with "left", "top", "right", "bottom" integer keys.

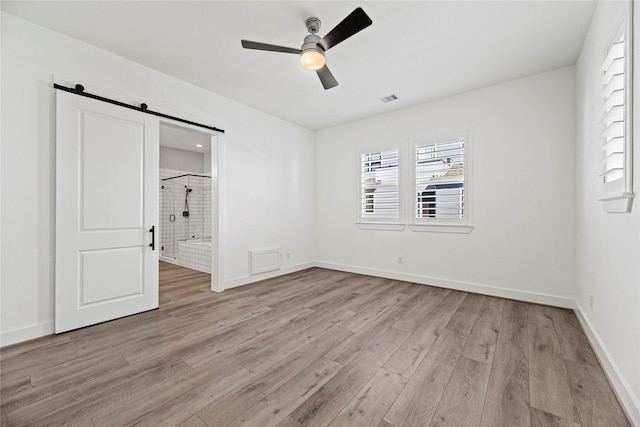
[{"left": 360, "top": 149, "right": 400, "bottom": 219}]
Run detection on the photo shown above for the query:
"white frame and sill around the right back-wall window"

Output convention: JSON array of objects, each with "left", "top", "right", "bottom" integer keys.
[{"left": 405, "top": 131, "right": 473, "bottom": 234}]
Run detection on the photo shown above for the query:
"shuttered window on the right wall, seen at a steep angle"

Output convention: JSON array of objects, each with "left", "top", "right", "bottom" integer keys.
[{"left": 600, "top": 23, "right": 633, "bottom": 212}]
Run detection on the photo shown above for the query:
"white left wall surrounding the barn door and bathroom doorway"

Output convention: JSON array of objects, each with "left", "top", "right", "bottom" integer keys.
[{"left": 0, "top": 13, "right": 314, "bottom": 345}]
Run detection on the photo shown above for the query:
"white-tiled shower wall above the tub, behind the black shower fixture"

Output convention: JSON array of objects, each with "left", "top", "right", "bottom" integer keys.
[{"left": 160, "top": 169, "right": 211, "bottom": 261}]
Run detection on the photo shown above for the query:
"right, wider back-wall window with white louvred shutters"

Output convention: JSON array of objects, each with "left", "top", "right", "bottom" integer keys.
[{"left": 412, "top": 137, "right": 471, "bottom": 233}]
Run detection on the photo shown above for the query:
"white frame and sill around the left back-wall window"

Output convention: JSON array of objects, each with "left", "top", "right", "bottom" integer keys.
[{"left": 356, "top": 142, "right": 406, "bottom": 231}]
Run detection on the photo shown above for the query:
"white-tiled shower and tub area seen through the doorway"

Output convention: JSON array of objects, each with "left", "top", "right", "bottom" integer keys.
[{"left": 160, "top": 169, "right": 211, "bottom": 273}]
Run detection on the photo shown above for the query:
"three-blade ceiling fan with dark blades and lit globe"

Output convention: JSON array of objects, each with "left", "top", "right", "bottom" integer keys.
[{"left": 242, "top": 8, "right": 373, "bottom": 89}]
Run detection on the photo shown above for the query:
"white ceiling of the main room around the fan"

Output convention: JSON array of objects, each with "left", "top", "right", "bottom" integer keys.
[{"left": 1, "top": 0, "right": 595, "bottom": 130}]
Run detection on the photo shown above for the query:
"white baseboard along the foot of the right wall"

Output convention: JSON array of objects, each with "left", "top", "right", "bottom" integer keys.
[{"left": 574, "top": 300, "right": 640, "bottom": 426}]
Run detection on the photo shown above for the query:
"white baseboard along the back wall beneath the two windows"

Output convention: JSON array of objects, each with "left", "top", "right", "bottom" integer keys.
[{"left": 315, "top": 261, "right": 575, "bottom": 308}]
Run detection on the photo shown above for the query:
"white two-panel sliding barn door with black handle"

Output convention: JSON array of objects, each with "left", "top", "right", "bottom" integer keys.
[{"left": 55, "top": 90, "right": 159, "bottom": 333}]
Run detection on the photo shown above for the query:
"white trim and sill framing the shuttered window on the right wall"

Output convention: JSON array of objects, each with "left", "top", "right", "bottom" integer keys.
[{"left": 598, "top": 10, "right": 634, "bottom": 213}]
